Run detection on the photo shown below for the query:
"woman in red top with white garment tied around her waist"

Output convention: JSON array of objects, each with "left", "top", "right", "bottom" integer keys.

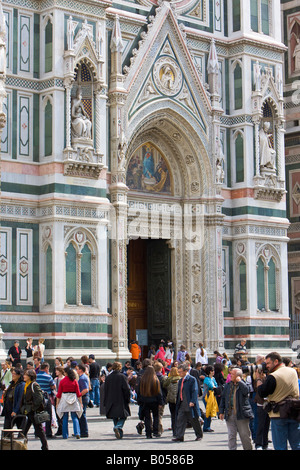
[{"left": 56, "top": 367, "right": 82, "bottom": 439}]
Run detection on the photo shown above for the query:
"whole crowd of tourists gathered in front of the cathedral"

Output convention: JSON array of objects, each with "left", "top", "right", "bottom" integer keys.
[{"left": 0, "top": 339, "right": 300, "bottom": 450}]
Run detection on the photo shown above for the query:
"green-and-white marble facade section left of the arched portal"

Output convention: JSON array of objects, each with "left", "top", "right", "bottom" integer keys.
[{"left": 0, "top": 1, "right": 114, "bottom": 358}]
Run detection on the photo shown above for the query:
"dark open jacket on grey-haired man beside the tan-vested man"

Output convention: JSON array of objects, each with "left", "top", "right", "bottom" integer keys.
[{"left": 219, "top": 380, "right": 254, "bottom": 420}]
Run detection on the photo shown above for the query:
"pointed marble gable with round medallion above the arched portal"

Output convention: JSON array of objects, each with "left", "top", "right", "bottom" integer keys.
[{"left": 124, "top": 2, "right": 211, "bottom": 134}]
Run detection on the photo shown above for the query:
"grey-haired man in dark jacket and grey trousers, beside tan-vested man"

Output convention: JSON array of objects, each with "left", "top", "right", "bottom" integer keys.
[{"left": 219, "top": 368, "right": 253, "bottom": 450}]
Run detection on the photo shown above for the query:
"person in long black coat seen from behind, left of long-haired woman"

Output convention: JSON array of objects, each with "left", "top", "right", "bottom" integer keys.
[{"left": 104, "top": 362, "right": 130, "bottom": 439}]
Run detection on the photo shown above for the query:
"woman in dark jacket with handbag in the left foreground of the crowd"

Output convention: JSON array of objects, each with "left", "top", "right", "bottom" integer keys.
[{"left": 21, "top": 369, "right": 50, "bottom": 450}]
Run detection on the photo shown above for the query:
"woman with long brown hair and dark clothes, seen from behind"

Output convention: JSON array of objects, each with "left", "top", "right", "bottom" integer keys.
[{"left": 137, "top": 366, "right": 163, "bottom": 439}]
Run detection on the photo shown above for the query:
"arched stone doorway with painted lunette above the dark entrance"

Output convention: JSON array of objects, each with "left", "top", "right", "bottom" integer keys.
[{"left": 122, "top": 110, "right": 221, "bottom": 356}]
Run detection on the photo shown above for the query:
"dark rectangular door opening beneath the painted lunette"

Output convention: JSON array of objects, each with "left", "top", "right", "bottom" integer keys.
[{"left": 127, "top": 238, "right": 172, "bottom": 358}]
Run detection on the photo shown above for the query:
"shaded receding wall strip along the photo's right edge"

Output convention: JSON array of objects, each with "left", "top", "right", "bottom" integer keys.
[{"left": 281, "top": 1, "right": 300, "bottom": 343}]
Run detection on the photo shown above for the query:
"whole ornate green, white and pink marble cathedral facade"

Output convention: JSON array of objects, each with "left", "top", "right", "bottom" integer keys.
[{"left": 0, "top": 0, "right": 296, "bottom": 360}]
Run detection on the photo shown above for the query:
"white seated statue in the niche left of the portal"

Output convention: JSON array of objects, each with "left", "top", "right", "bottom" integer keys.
[{"left": 71, "top": 87, "right": 92, "bottom": 139}]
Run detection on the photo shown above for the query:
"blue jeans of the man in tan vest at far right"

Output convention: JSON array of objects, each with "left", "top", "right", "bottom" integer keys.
[{"left": 271, "top": 418, "right": 300, "bottom": 450}]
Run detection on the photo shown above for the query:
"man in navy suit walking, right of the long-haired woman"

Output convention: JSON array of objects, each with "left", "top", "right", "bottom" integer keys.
[{"left": 172, "top": 363, "right": 203, "bottom": 442}]
